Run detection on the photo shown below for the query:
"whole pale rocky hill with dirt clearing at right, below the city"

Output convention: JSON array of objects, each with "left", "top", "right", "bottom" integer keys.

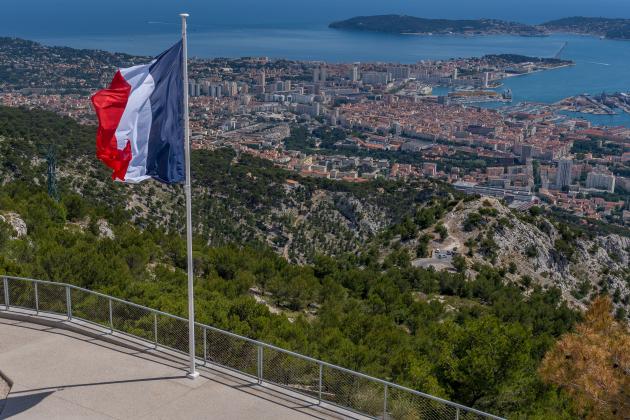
[{"left": 373, "top": 197, "right": 630, "bottom": 320}]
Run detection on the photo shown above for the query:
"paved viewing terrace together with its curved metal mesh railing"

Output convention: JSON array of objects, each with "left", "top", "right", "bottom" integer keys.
[{"left": 0, "top": 276, "right": 502, "bottom": 420}]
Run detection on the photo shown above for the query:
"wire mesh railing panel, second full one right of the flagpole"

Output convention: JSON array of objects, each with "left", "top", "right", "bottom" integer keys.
[{"left": 263, "top": 348, "right": 319, "bottom": 397}]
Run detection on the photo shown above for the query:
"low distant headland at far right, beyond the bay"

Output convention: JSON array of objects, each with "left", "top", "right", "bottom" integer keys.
[{"left": 540, "top": 16, "right": 630, "bottom": 39}]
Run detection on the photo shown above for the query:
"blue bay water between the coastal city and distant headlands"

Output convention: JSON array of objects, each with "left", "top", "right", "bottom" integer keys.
[{"left": 6, "top": 19, "right": 630, "bottom": 127}]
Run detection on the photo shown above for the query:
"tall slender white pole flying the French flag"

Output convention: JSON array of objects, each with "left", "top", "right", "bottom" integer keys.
[{"left": 179, "top": 13, "right": 199, "bottom": 379}]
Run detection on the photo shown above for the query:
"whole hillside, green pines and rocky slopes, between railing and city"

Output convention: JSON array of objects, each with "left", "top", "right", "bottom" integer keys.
[{"left": 0, "top": 98, "right": 628, "bottom": 419}]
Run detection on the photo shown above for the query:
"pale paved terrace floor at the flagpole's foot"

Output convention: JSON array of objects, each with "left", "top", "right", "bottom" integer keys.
[{"left": 0, "top": 312, "right": 362, "bottom": 420}]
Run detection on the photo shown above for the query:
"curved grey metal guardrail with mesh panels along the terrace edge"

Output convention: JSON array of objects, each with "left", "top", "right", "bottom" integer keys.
[{"left": 0, "top": 276, "right": 503, "bottom": 420}]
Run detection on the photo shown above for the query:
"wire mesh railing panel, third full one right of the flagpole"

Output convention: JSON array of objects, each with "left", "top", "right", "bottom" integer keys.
[{"left": 322, "top": 366, "right": 385, "bottom": 417}]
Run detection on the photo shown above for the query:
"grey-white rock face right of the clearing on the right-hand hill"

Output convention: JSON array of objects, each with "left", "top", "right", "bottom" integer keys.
[{"left": 447, "top": 198, "right": 630, "bottom": 307}]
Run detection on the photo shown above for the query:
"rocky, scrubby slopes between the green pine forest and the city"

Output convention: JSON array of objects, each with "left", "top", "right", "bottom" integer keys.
[{"left": 0, "top": 108, "right": 630, "bottom": 310}]
